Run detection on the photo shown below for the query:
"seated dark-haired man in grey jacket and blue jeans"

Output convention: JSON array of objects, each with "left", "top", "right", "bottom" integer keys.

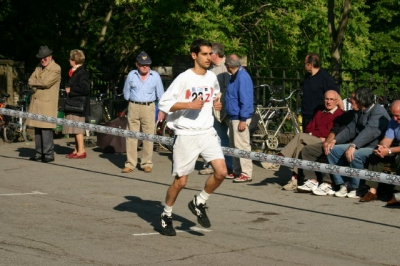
[{"left": 327, "top": 88, "right": 390, "bottom": 198}]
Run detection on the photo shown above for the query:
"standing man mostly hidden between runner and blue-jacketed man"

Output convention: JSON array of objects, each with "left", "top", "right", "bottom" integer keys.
[{"left": 199, "top": 42, "right": 233, "bottom": 175}]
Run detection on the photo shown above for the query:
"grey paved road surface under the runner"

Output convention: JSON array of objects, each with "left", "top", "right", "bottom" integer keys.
[{"left": 0, "top": 139, "right": 400, "bottom": 265}]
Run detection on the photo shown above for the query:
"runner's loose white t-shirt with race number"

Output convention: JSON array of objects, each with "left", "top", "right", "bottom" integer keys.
[{"left": 158, "top": 69, "right": 220, "bottom": 135}]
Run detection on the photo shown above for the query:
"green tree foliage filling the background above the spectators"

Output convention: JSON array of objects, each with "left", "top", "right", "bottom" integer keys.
[{"left": 0, "top": 0, "right": 400, "bottom": 90}]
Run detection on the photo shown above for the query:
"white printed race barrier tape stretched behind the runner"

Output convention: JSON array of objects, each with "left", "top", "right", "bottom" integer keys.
[{"left": 0, "top": 108, "right": 400, "bottom": 185}]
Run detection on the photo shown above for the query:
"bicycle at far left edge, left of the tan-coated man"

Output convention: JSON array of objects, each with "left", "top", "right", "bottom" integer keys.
[{"left": 2, "top": 91, "right": 33, "bottom": 143}]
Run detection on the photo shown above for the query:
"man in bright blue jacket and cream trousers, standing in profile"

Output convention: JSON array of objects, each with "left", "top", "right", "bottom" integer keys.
[{"left": 225, "top": 54, "right": 254, "bottom": 183}]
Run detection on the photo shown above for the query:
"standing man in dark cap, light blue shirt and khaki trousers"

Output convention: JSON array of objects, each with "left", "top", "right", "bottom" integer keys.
[{"left": 121, "top": 52, "right": 165, "bottom": 173}]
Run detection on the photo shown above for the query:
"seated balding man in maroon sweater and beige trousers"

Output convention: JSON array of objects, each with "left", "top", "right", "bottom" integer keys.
[{"left": 281, "top": 90, "right": 343, "bottom": 190}]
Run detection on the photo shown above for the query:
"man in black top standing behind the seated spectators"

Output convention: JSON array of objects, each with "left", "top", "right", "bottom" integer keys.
[{"left": 301, "top": 53, "right": 340, "bottom": 130}]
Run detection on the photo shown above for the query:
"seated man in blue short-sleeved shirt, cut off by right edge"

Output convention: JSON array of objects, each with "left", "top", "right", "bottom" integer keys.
[{"left": 360, "top": 100, "right": 400, "bottom": 205}]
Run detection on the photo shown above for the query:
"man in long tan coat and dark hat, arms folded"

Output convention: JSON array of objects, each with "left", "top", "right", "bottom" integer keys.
[{"left": 27, "top": 46, "right": 61, "bottom": 163}]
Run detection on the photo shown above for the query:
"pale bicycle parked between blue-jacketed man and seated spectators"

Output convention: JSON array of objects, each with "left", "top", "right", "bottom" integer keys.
[{"left": 251, "top": 84, "right": 301, "bottom": 153}]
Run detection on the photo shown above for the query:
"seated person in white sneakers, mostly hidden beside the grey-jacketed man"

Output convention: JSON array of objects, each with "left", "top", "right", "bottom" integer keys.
[{"left": 297, "top": 93, "right": 358, "bottom": 196}]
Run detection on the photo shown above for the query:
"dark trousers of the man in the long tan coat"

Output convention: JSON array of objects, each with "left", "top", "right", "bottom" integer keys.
[{"left": 35, "top": 128, "right": 54, "bottom": 158}]
